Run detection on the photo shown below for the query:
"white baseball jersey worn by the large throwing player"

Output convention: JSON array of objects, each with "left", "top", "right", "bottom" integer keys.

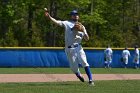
[{"left": 57, "top": 20, "right": 87, "bottom": 46}]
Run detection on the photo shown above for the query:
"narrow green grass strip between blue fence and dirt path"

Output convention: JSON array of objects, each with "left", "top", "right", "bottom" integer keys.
[{"left": 0, "top": 68, "right": 140, "bottom": 74}]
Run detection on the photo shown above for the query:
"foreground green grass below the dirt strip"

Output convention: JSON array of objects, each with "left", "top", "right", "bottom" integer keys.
[{"left": 0, "top": 80, "right": 140, "bottom": 93}]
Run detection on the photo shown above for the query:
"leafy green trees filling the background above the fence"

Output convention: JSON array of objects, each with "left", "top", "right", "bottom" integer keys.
[{"left": 0, "top": 0, "right": 140, "bottom": 47}]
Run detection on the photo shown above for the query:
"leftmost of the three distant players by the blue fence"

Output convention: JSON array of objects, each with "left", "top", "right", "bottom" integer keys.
[{"left": 104, "top": 45, "right": 113, "bottom": 68}]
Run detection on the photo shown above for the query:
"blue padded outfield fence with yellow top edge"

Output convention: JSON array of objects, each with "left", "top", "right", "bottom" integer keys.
[{"left": 0, "top": 48, "right": 138, "bottom": 67}]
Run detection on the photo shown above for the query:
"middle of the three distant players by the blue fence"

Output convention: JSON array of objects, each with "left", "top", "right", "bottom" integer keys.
[{"left": 122, "top": 47, "right": 130, "bottom": 68}]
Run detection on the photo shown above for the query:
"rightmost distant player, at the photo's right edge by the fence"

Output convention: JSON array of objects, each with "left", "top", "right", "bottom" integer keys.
[{"left": 133, "top": 45, "right": 140, "bottom": 69}]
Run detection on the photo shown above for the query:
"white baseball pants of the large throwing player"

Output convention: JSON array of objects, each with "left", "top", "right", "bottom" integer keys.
[{"left": 65, "top": 45, "right": 89, "bottom": 73}]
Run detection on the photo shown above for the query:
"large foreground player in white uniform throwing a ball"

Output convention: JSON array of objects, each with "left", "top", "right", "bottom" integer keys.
[{"left": 45, "top": 10, "right": 94, "bottom": 85}]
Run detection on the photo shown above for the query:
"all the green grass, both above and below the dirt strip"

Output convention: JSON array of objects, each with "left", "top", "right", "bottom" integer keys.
[{"left": 0, "top": 68, "right": 140, "bottom": 93}]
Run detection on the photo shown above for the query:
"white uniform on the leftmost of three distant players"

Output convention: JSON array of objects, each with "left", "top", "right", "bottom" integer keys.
[{"left": 104, "top": 48, "right": 113, "bottom": 64}]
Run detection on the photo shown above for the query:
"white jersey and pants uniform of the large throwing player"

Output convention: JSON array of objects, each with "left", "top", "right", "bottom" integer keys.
[{"left": 57, "top": 21, "right": 89, "bottom": 73}]
